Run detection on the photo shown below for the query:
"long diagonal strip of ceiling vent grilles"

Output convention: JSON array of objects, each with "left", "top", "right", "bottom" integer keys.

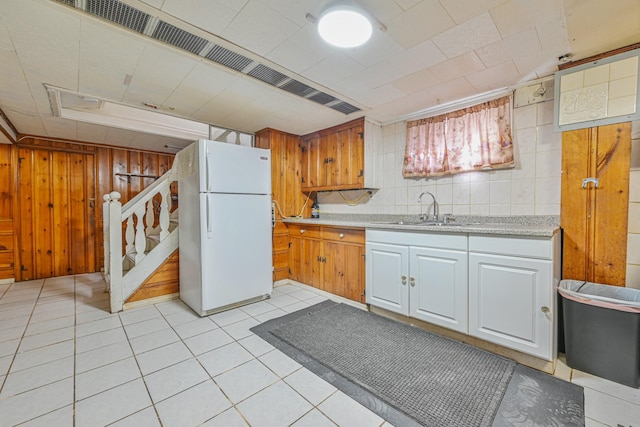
[{"left": 52, "top": 0, "right": 360, "bottom": 114}]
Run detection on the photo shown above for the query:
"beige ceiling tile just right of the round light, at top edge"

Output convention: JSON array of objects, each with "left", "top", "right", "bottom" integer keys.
[{"left": 387, "top": 0, "right": 455, "bottom": 49}]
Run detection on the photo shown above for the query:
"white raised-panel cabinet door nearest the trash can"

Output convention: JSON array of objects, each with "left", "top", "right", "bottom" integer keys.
[{"left": 469, "top": 253, "right": 555, "bottom": 360}]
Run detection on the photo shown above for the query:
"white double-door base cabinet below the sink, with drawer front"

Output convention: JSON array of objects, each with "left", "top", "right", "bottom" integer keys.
[{"left": 366, "top": 230, "right": 467, "bottom": 333}]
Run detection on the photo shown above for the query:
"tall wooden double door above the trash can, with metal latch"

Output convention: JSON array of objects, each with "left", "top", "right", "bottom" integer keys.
[{"left": 560, "top": 123, "right": 631, "bottom": 286}]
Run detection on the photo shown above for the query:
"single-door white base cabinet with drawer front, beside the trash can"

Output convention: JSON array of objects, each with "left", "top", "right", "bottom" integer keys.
[{"left": 469, "top": 235, "right": 560, "bottom": 360}]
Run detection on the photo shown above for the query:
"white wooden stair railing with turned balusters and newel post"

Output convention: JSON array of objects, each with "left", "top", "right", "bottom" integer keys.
[{"left": 103, "top": 171, "right": 178, "bottom": 313}]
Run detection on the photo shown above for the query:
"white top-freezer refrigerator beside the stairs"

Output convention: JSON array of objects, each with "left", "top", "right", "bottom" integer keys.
[{"left": 178, "top": 140, "right": 273, "bottom": 316}]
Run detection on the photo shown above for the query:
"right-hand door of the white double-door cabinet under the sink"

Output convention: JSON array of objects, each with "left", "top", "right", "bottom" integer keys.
[{"left": 409, "top": 246, "right": 468, "bottom": 333}]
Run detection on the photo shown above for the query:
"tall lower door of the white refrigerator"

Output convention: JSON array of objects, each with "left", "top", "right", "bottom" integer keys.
[{"left": 200, "top": 193, "right": 273, "bottom": 312}]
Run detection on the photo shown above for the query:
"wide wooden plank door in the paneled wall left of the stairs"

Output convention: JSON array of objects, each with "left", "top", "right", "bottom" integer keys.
[{"left": 16, "top": 148, "right": 96, "bottom": 281}]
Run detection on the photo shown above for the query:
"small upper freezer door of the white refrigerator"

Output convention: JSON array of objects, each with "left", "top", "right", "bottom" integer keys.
[{"left": 198, "top": 140, "right": 271, "bottom": 194}]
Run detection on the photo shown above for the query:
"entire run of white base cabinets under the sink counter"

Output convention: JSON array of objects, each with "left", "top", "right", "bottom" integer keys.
[{"left": 366, "top": 230, "right": 560, "bottom": 361}]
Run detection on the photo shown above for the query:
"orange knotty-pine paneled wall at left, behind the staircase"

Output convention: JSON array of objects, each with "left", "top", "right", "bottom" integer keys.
[{"left": 5, "top": 138, "right": 178, "bottom": 284}]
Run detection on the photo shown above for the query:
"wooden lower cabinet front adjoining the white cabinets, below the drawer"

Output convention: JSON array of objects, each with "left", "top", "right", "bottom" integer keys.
[{"left": 322, "top": 241, "right": 365, "bottom": 302}]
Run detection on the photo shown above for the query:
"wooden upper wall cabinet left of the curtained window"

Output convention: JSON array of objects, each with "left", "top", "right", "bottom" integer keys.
[{"left": 301, "top": 119, "right": 364, "bottom": 191}]
